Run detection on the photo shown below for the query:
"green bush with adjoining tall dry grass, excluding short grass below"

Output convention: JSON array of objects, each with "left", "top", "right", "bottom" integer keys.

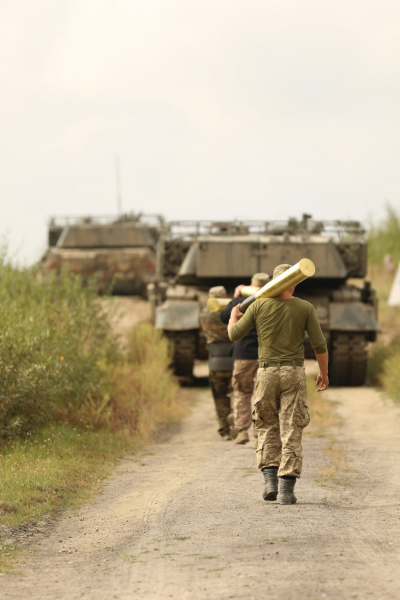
[{"left": 0, "top": 252, "right": 182, "bottom": 440}]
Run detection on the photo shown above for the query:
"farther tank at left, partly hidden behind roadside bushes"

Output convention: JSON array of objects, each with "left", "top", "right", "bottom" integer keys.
[{"left": 43, "top": 215, "right": 161, "bottom": 295}]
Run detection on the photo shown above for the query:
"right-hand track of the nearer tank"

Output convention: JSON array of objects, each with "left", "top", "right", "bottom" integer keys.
[{"left": 329, "top": 332, "right": 368, "bottom": 386}]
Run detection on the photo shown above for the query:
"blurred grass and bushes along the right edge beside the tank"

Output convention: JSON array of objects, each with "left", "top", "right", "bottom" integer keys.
[{"left": 368, "top": 206, "right": 400, "bottom": 401}]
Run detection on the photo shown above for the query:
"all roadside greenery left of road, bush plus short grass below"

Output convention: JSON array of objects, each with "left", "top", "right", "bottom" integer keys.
[{"left": 0, "top": 254, "right": 184, "bottom": 568}]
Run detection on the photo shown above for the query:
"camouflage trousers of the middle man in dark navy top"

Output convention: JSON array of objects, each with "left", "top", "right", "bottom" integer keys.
[{"left": 232, "top": 359, "right": 258, "bottom": 431}]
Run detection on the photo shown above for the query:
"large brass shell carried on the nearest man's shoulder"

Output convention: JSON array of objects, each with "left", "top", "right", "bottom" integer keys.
[{"left": 239, "top": 258, "right": 315, "bottom": 313}]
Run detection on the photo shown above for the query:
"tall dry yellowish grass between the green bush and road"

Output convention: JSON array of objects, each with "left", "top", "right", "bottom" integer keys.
[{"left": 66, "top": 323, "right": 183, "bottom": 440}]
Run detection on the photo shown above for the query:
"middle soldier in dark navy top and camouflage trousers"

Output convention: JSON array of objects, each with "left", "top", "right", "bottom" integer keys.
[{"left": 221, "top": 273, "right": 270, "bottom": 444}]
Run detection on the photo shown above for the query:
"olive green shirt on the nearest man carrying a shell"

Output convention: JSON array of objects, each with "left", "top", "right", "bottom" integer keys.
[{"left": 230, "top": 298, "right": 327, "bottom": 362}]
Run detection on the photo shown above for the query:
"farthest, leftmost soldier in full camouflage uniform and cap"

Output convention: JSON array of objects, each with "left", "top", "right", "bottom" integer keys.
[{"left": 200, "top": 285, "right": 233, "bottom": 440}]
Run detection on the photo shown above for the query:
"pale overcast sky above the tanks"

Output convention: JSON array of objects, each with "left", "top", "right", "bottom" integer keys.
[{"left": 0, "top": 0, "right": 400, "bottom": 262}]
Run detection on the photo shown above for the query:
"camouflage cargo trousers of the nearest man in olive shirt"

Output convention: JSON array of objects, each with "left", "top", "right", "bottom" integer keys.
[{"left": 253, "top": 366, "right": 310, "bottom": 477}]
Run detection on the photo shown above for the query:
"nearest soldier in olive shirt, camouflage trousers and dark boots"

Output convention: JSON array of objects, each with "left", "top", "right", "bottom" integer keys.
[{"left": 228, "top": 265, "right": 329, "bottom": 504}]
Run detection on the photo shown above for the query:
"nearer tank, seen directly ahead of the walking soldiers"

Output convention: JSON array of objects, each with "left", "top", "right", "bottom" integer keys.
[{"left": 149, "top": 215, "right": 378, "bottom": 386}]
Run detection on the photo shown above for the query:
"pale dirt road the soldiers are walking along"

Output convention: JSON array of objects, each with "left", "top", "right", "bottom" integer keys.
[{"left": 4, "top": 378, "right": 400, "bottom": 600}]
